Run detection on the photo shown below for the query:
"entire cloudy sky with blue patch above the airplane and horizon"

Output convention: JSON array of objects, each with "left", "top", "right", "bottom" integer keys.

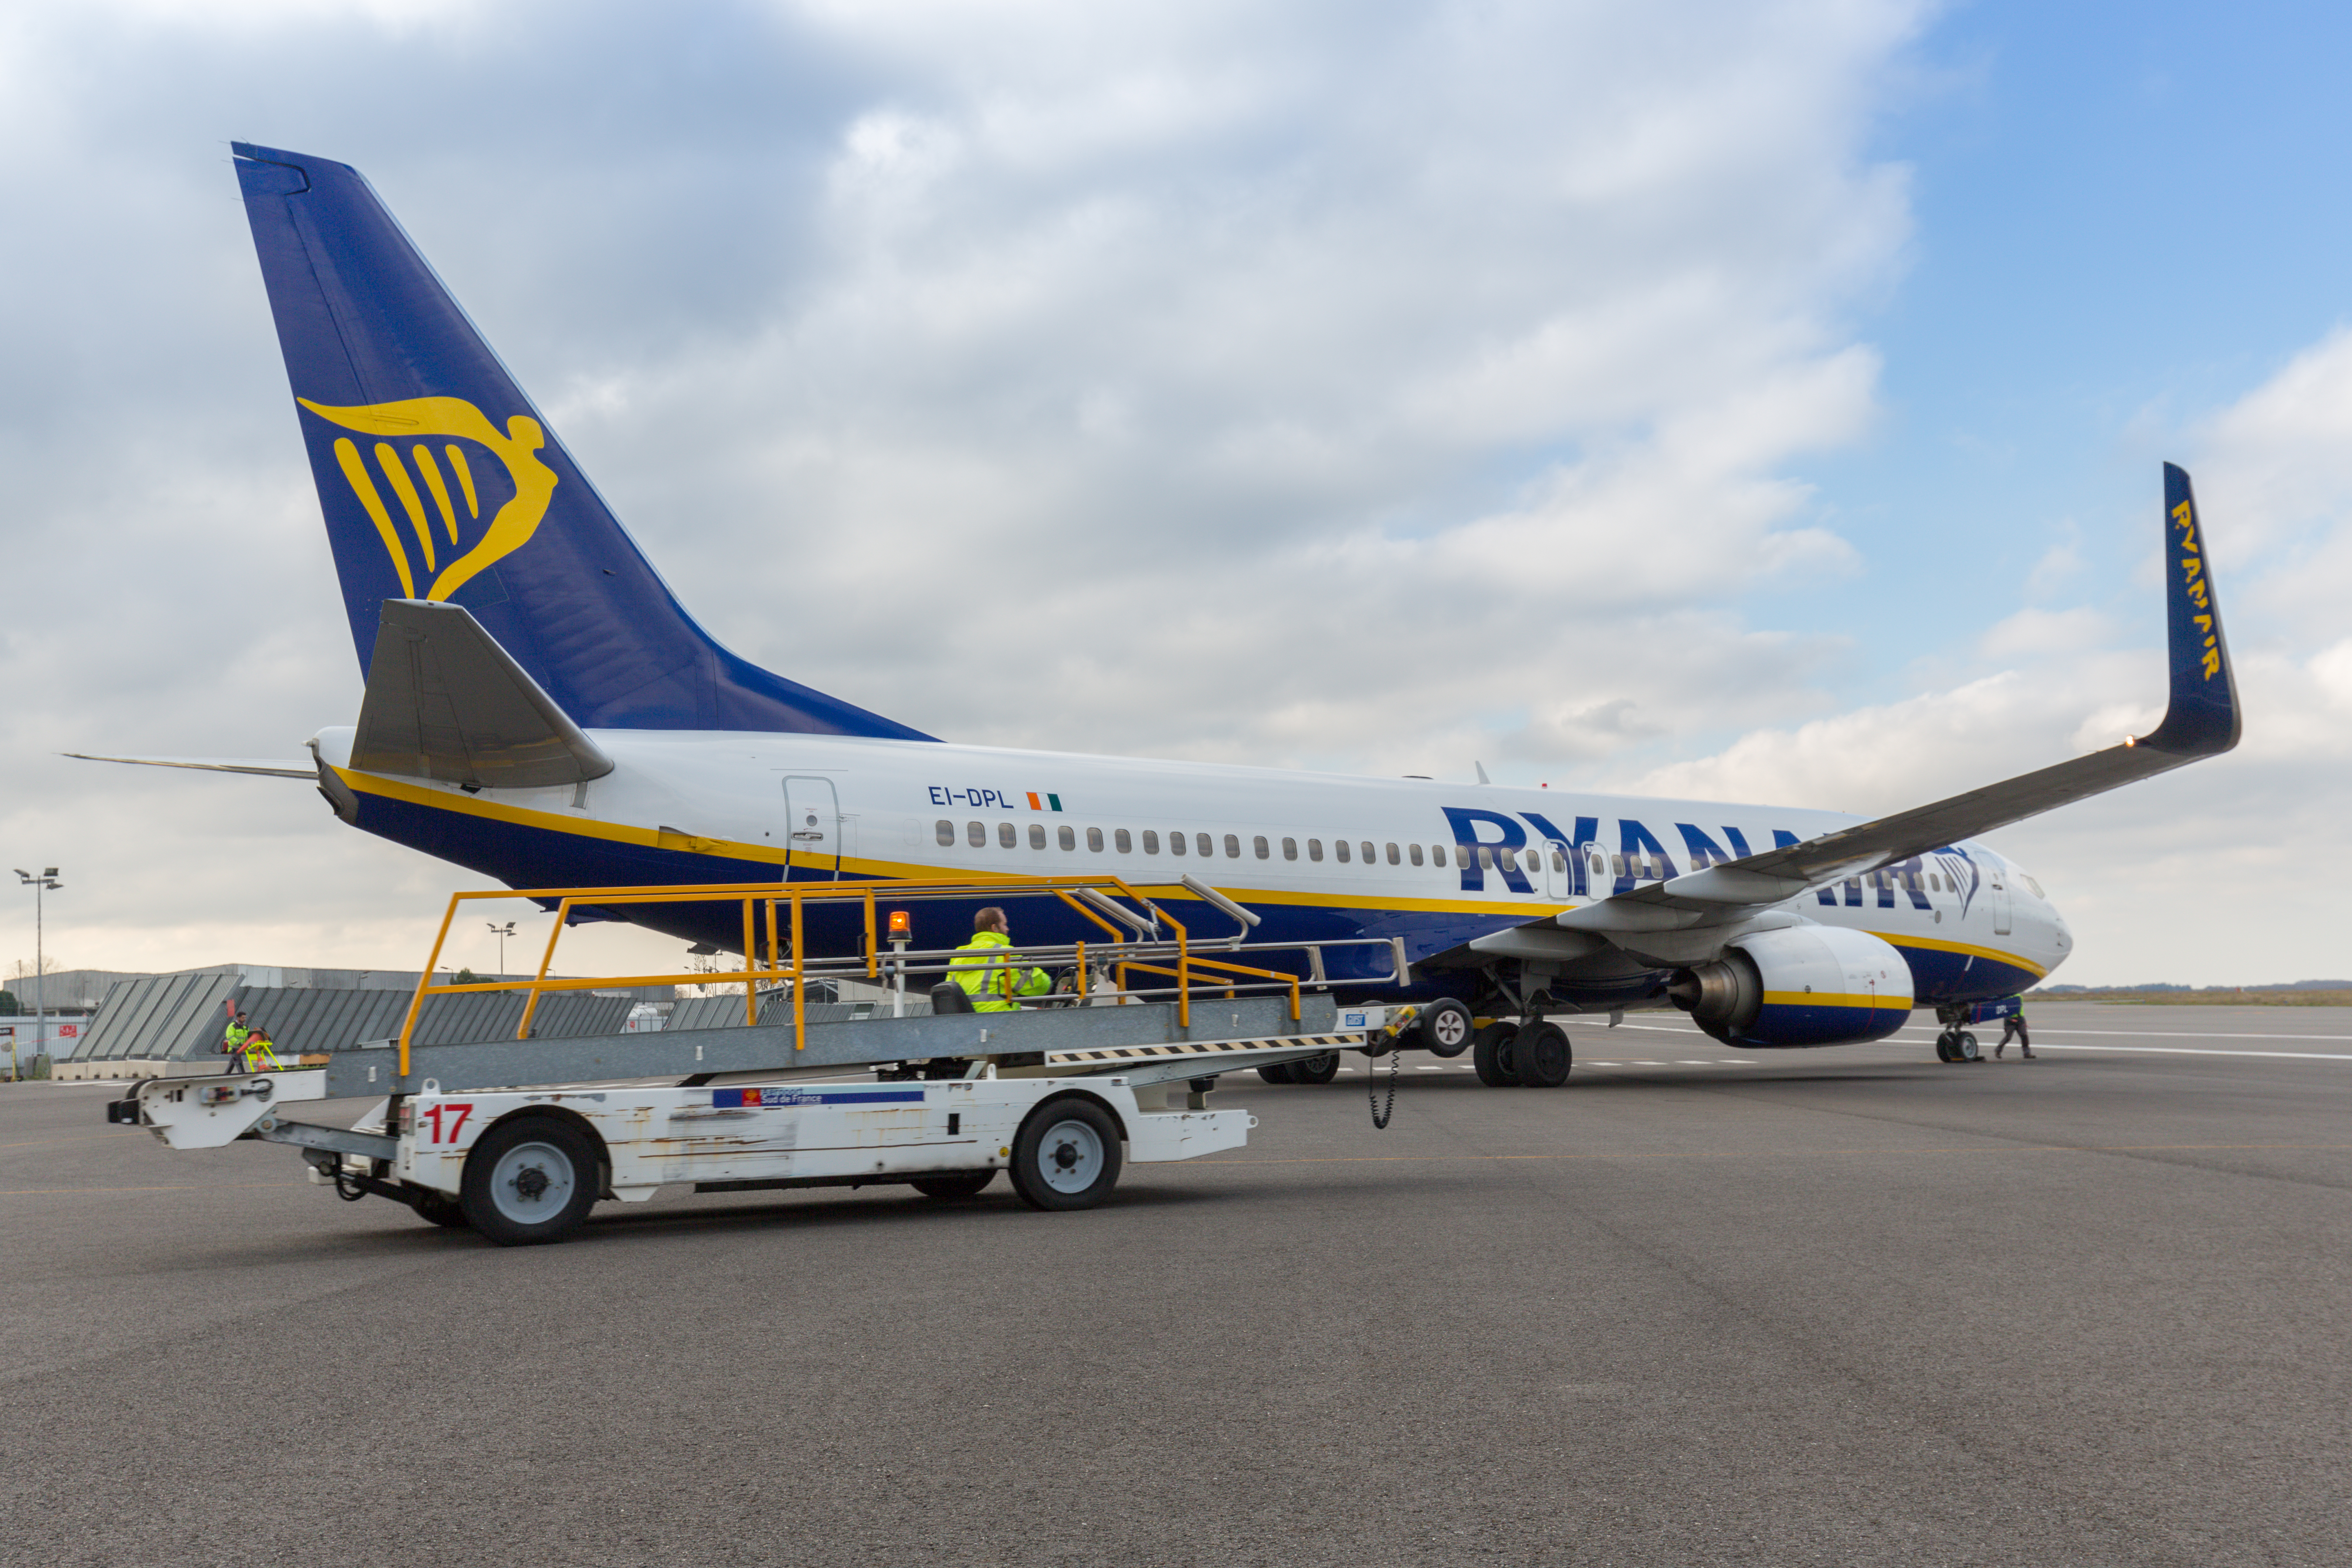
[{"left": 0, "top": 0, "right": 2352, "bottom": 982}]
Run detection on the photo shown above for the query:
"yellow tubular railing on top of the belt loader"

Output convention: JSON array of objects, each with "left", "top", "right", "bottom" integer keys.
[{"left": 400, "top": 877, "right": 1301, "bottom": 1077}]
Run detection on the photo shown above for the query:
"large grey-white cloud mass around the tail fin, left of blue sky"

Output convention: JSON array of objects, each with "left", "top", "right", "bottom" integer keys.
[{"left": 0, "top": 0, "right": 1928, "bottom": 964}]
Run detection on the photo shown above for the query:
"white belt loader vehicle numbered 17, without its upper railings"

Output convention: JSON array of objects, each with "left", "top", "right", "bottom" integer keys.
[{"left": 108, "top": 997, "right": 1366, "bottom": 1243}]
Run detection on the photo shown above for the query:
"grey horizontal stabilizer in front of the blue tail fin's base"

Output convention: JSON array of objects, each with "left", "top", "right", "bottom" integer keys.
[{"left": 350, "top": 599, "right": 611, "bottom": 790}]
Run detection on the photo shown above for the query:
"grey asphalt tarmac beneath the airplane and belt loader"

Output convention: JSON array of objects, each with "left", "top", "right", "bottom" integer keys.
[{"left": 0, "top": 1004, "right": 2352, "bottom": 1568}]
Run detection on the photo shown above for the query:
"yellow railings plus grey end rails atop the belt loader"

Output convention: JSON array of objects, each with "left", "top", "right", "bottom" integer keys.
[{"left": 400, "top": 874, "right": 1406, "bottom": 1077}]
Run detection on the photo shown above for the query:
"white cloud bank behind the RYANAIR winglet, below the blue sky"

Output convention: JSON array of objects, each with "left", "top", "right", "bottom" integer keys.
[{"left": 1635, "top": 332, "right": 2352, "bottom": 985}]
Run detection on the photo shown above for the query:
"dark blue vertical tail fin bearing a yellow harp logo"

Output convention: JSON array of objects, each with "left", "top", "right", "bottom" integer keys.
[{"left": 233, "top": 141, "right": 932, "bottom": 741}]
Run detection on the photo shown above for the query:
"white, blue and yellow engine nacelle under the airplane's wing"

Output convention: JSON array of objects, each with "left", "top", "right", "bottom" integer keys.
[{"left": 1665, "top": 924, "right": 1912, "bottom": 1046}]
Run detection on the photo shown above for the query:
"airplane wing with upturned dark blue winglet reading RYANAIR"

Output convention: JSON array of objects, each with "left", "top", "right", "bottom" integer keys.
[{"left": 1524, "top": 463, "right": 2241, "bottom": 948}]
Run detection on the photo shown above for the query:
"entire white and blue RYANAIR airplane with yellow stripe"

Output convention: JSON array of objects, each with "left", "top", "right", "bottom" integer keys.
[{"left": 78, "top": 143, "right": 2239, "bottom": 1084}]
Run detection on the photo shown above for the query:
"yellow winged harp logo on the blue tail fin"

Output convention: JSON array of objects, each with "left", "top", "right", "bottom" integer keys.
[{"left": 294, "top": 397, "right": 555, "bottom": 602}]
